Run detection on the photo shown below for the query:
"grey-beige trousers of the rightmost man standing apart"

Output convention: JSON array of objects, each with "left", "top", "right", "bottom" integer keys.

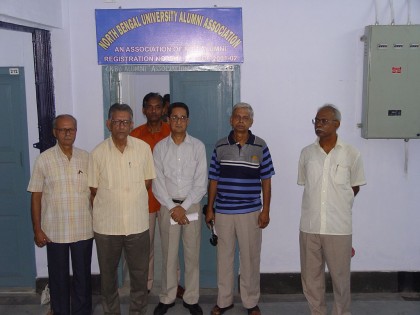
[{"left": 299, "top": 232, "right": 352, "bottom": 315}]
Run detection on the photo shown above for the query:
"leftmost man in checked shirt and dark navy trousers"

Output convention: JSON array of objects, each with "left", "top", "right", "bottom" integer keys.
[{"left": 28, "top": 115, "right": 93, "bottom": 315}]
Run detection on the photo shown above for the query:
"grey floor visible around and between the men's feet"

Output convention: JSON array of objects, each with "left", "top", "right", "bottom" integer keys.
[{"left": 0, "top": 290, "right": 420, "bottom": 315}]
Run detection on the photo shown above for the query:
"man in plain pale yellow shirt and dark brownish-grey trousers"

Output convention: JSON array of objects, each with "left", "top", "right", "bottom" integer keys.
[{"left": 88, "top": 103, "right": 155, "bottom": 314}]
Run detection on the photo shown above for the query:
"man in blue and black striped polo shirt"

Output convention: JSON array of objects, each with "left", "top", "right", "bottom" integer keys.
[{"left": 206, "top": 103, "right": 274, "bottom": 315}]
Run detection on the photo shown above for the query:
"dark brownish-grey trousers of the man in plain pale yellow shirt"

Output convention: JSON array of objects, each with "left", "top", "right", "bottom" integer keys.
[{"left": 95, "top": 230, "right": 150, "bottom": 315}]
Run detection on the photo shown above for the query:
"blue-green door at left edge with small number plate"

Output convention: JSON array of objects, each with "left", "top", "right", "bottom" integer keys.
[{"left": 0, "top": 67, "right": 35, "bottom": 288}]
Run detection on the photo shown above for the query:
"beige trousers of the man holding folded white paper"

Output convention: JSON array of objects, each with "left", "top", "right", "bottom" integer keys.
[{"left": 159, "top": 204, "right": 202, "bottom": 304}]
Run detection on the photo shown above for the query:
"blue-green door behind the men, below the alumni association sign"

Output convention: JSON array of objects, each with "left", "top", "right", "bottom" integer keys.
[{"left": 170, "top": 71, "right": 239, "bottom": 288}]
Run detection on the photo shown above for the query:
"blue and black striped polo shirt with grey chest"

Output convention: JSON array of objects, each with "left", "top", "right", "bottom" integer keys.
[{"left": 209, "top": 131, "right": 275, "bottom": 214}]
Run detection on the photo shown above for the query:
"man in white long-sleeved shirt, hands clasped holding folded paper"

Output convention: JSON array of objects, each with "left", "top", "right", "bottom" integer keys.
[{"left": 153, "top": 103, "right": 207, "bottom": 315}]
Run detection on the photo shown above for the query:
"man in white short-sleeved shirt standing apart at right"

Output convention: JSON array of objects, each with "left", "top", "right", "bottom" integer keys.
[{"left": 297, "top": 104, "right": 366, "bottom": 315}]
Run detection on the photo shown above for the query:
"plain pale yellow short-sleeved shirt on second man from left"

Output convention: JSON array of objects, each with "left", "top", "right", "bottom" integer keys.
[{"left": 88, "top": 136, "right": 155, "bottom": 235}]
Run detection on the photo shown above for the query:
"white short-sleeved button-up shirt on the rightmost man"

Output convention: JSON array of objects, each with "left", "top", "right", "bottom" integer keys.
[{"left": 297, "top": 138, "right": 366, "bottom": 235}]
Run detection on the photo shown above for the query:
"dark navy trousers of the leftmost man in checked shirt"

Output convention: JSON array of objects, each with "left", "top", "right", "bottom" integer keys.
[{"left": 47, "top": 238, "right": 93, "bottom": 315}]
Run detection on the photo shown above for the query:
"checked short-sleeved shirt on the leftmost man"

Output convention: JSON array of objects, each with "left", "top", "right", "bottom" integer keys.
[{"left": 28, "top": 144, "right": 93, "bottom": 243}]
